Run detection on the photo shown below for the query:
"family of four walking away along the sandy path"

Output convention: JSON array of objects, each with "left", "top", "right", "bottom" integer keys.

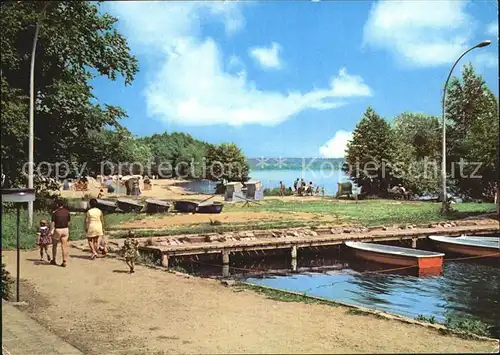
[{"left": 37, "top": 199, "right": 138, "bottom": 273}]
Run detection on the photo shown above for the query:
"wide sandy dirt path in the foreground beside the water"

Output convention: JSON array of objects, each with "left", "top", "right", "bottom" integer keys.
[{"left": 3, "top": 249, "right": 495, "bottom": 354}]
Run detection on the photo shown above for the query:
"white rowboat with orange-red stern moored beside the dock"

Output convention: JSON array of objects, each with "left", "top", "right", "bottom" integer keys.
[{"left": 345, "top": 242, "right": 444, "bottom": 269}]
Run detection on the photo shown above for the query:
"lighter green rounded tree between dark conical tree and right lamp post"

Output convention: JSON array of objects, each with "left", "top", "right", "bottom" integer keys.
[{"left": 392, "top": 112, "right": 441, "bottom": 194}]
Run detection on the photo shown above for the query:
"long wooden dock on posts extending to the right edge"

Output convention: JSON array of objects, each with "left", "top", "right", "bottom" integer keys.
[{"left": 139, "top": 224, "right": 500, "bottom": 268}]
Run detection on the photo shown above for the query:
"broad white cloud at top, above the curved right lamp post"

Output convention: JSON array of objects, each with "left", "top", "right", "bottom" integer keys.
[{"left": 363, "top": 0, "right": 474, "bottom": 67}]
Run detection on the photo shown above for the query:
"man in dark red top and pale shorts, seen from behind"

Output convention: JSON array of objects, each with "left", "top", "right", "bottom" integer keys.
[{"left": 50, "top": 200, "right": 71, "bottom": 267}]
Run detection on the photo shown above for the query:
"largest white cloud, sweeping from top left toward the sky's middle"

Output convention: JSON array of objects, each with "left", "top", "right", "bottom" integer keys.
[{"left": 109, "top": 2, "right": 372, "bottom": 126}]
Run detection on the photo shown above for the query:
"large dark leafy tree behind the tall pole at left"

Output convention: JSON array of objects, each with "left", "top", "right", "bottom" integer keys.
[{"left": 1, "top": 1, "right": 138, "bottom": 183}]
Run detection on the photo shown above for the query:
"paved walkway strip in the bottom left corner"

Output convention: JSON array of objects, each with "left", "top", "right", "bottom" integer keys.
[{"left": 2, "top": 301, "right": 83, "bottom": 355}]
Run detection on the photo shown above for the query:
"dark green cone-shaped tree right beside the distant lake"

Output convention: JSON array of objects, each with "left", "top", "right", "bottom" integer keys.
[{"left": 343, "top": 107, "right": 395, "bottom": 195}]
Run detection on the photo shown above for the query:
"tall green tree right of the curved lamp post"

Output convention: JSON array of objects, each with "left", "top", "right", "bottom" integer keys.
[{"left": 446, "top": 63, "right": 499, "bottom": 200}]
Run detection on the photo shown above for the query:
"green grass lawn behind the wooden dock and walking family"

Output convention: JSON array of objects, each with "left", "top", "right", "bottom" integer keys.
[{"left": 2, "top": 199, "right": 495, "bottom": 249}]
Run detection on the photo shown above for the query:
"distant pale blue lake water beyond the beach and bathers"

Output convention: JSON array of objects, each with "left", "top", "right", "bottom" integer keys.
[{"left": 179, "top": 169, "right": 356, "bottom": 195}]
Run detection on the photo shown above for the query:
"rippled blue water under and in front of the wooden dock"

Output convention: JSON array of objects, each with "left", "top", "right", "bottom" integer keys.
[{"left": 172, "top": 241, "right": 500, "bottom": 337}]
